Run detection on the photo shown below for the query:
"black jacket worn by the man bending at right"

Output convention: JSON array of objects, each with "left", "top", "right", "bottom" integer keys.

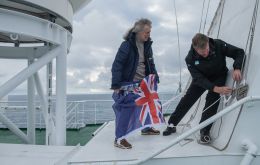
[{"left": 185, "top": 38, "right": 245, "bottom": 91}]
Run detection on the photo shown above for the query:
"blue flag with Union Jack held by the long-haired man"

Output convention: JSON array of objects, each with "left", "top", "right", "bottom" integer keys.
[{"left": 113, "top": 74, "right": 165, "bottom": 139}]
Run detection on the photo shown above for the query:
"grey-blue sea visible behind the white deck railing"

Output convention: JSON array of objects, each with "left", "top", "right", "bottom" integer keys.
[{"left": 0, "top": 93, "right": 178, "bottom": 128}]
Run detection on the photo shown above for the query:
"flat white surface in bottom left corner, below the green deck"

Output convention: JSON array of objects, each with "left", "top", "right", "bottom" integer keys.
[{"left": 0, "top": 144, "right": 75, "bottom": 165}]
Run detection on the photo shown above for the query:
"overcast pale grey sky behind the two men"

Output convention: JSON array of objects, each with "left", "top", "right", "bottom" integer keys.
[{"left": 0, "top": 0, "right": 219, "bottom": 94}]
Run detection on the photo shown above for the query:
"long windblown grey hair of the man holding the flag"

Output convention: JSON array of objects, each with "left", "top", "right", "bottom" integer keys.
[{"left": 124, "top": 18, "right": 152, "bottom": 39}]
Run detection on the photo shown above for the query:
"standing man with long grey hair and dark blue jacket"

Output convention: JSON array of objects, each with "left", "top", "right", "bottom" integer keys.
[{"left": 111, "top": 18, "right": 160, "bottom": 149}]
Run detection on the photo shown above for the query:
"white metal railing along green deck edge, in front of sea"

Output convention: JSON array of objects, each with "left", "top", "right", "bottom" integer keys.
[{"left": 0, "top": 97, "right": 177, "bottom": 129}]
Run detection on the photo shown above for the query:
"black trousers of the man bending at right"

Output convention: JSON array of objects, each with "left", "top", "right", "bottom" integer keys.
[{"left": 168, "top": 76, "right": 226, "bottom": 133}]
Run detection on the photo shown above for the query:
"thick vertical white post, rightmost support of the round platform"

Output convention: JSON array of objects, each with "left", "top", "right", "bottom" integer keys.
[{"left": 55, "top": 31, "right": 67, "bottom": 145}]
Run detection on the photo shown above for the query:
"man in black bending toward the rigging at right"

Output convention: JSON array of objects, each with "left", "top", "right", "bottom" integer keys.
[{"left": 163, "top": 33, "right": 245, "bottom": 143}]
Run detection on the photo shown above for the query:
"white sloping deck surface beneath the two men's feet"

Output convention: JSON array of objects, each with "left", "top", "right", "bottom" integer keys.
[{"left": 69, "top": 122, "right": 220, "bottom": 164}]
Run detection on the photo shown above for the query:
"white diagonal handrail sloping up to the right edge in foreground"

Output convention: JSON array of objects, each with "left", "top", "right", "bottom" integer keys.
[{"left": 131, "top": 96, "right": 260, "bottom": 164}]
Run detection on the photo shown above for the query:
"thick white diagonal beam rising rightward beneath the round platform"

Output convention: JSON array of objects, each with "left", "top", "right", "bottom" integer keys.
[{"left": 0, "top": 48, "right": 59, "bottom": 98}]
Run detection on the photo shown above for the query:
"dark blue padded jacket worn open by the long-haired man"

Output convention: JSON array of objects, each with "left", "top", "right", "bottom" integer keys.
[{"left": 111, "top": 32, "right": 159, "bottom": 89}]
